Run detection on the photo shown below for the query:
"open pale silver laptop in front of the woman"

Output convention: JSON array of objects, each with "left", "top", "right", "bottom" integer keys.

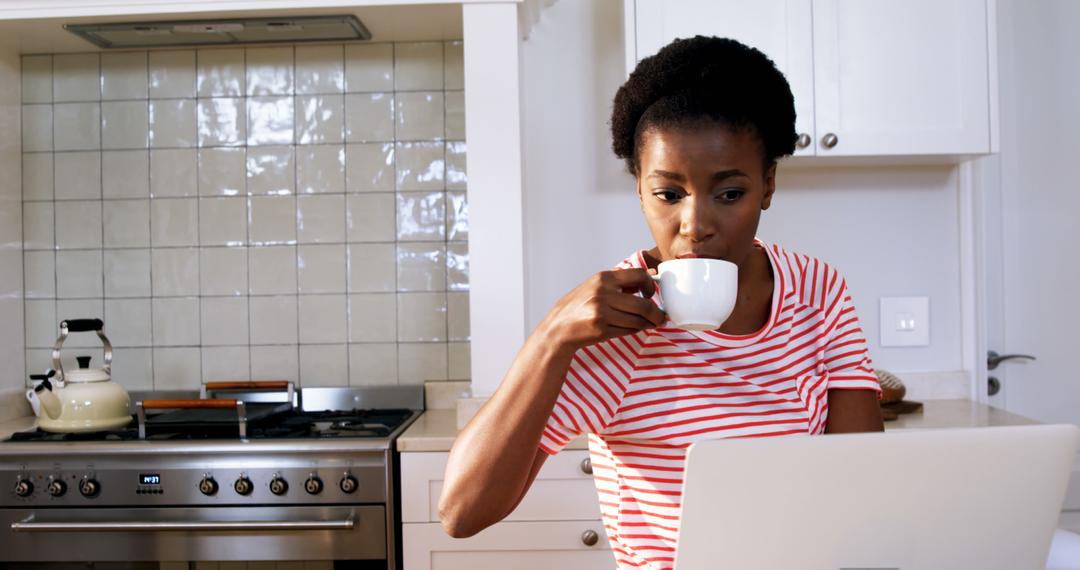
[{"left": 675, "top": 424, "right": 1080, "bottom": 570}]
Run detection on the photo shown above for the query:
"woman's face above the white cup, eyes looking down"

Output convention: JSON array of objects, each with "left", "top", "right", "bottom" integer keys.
[{"left": 637, "top": 124, "right": 777, "bottom": 266}]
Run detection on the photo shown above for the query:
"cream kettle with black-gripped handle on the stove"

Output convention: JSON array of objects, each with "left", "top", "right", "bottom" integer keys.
[{"left": 26, "top": 318, "right": 132, "bottom": 432}]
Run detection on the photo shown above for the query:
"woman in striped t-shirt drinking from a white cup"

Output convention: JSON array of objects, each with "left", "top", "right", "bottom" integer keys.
[{"left": 440, "top": 37, "right": 881, "bottom": 569}]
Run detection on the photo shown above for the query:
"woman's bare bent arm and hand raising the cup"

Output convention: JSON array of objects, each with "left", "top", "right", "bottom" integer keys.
[{"left": 438, "top": 269, "right": 665, "bottom": 538}]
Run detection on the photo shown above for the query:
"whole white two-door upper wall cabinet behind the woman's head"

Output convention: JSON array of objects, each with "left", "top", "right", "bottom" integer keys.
[{"left": 626, "top": 0, "right": 997, "bottom": 157}]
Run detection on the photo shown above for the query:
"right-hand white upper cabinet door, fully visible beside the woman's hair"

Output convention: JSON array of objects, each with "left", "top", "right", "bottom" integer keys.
[{"left": 813, "top": 0, "right": 990, "bottom": 157}]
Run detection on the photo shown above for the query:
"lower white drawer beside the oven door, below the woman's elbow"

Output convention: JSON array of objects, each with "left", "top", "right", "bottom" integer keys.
[{"left": 402, "top": 520, "right": 615, "bottom": 570}]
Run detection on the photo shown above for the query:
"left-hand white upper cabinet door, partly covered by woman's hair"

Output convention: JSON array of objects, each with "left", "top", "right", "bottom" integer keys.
[{"left": 626, "top": 0, "right": 816, "bottom": 155}]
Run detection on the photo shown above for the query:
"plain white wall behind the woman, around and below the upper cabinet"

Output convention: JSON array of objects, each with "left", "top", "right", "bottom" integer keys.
[{"left": 523, "top": 0, "right": 961, "bottom": 371}]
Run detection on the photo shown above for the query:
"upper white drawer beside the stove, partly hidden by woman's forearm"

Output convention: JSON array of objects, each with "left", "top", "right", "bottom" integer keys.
[{"left": 401, "top": 449, "right": 600, "bottom": 523}]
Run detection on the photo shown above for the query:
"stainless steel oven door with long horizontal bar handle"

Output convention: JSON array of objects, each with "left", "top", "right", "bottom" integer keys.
[{"left": 0, "top": 505, "right": 387, "bottom": 561}]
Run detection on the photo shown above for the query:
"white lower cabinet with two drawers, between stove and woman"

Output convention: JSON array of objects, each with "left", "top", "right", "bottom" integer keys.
[{"left": 401, "top": 450, "right": 615, "bottom": 570}]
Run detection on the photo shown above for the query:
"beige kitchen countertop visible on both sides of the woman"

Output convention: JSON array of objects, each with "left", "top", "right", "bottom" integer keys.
[{"left": 399, "top": 399, "right": 1038, "bottom": 452}]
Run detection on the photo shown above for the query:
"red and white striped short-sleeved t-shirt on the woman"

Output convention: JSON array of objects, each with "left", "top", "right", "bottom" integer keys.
[{"left": 540, "top": 242, "right": 881, "bottom": 569}]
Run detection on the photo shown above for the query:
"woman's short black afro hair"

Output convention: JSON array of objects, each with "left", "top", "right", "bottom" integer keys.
[{"left": 611, "top": 36, "right": 797, "bottom": 176}]
